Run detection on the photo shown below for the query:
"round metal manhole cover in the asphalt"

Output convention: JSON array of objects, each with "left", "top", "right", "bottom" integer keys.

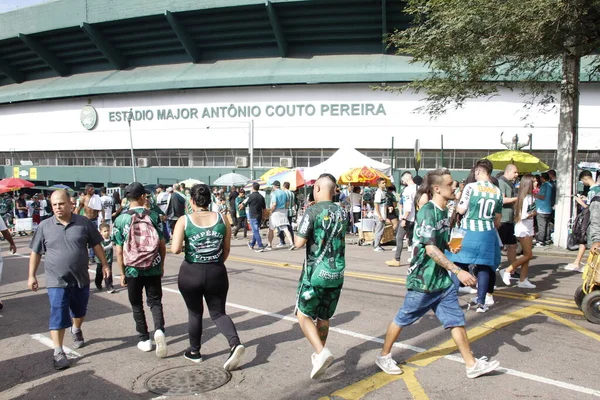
[{"left": 146, "top": 366, "right": 231, "bottom": 396}]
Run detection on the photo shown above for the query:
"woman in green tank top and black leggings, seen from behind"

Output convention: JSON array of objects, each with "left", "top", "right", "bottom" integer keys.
[{"left": 171, "top": 184, "right": 245, "bottom": 371}]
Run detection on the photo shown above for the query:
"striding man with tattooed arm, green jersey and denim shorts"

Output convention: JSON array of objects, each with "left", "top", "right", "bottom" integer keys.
[{"left": 376, "top": 169, "right": 499, "bottom": 378}]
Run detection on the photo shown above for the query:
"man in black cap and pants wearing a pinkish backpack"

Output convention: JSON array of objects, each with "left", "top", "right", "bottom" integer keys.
[{"left": 113, "top": 182, "right": 167, "bottom": 358}]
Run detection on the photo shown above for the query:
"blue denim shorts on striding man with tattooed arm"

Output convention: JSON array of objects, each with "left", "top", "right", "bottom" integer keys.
[{"left": 394, "top": 285, "right": 465, "bottom": 329}]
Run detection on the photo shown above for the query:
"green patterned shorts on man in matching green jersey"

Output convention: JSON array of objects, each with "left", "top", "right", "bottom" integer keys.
[{"left": 296, "top": 282, "right": 342, "bottom": 321}]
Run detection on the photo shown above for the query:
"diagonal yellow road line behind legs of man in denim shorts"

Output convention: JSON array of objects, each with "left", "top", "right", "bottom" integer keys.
[{"left": 406, "top": 306, "right": 540, "bottom": 367}]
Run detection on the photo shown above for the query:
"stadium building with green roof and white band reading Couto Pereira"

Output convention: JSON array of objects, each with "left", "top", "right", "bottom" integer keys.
[{"left": 0, "top": 0, "right": 600, "bottom": 185}]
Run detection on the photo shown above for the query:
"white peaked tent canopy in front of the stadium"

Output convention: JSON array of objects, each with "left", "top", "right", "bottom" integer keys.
[{"left": 304, "top": 147, "right": 392, "bottom": 181}]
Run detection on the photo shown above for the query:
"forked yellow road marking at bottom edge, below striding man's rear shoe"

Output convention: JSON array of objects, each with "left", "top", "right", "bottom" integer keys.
[{"left": 330, "top": 365, "right": 429, "bottom": 400}]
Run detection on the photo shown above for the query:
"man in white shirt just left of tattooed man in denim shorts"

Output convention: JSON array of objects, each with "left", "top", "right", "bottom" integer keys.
[{"left": 386, "top": 171, "right": 417, "bottom": 267}]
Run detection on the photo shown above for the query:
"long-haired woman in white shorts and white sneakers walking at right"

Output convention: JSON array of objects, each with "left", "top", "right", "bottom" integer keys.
[{"left": 501, "top": 174, "right": 536, "bottom": 289}]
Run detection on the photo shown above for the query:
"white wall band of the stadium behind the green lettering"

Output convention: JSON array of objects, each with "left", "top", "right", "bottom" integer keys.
[{"left": 0, "top": 84, "right": 600, "bottom": 151}]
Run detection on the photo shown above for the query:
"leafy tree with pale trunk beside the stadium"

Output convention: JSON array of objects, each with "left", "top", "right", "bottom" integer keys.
[{"left": 386, "top": 0, "right": 600, "bottom": 246}]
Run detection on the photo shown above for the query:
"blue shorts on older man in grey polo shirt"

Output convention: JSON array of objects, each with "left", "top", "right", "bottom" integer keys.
[{"left": 48, "top": 285, "right": 90, "bottom": 331}]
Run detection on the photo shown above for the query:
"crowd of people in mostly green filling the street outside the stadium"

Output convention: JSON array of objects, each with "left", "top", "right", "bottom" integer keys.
[{"left": 0, "top": 160, "right": 600, "bottom": 379}]
